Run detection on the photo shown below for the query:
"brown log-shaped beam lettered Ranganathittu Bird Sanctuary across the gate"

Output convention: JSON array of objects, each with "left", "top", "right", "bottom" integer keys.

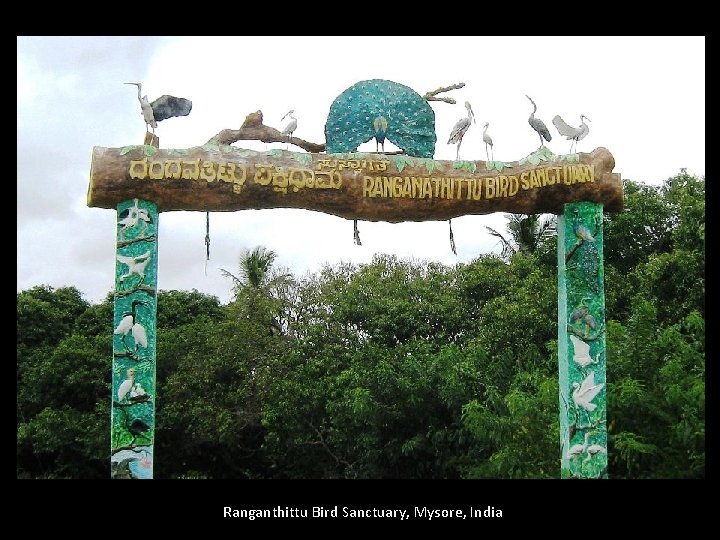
[{"left": 87, "top": 146, "right": 623, "bottom": 223}]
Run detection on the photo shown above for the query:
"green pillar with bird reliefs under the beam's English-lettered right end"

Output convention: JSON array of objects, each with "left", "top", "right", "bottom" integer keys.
[{"left": 558, "top": 202, "right": 607, "bottom": 478}]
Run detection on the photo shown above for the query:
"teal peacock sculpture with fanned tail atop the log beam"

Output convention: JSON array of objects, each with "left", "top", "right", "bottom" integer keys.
[{"left": 325, "top": 79, "right": 437, "bottom": 158}]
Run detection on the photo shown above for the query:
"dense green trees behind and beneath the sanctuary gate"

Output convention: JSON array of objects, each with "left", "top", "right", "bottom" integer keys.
[{"left": 17, "top": 173, "right": 705, "bottom": 478}]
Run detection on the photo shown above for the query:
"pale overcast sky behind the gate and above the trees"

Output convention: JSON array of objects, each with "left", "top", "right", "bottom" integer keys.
[{"left": 17, "top": 36, "right": 705, "bottom": 303}]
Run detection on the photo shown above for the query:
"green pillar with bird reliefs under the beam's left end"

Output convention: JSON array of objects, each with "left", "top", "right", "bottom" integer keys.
[{"left": 110, "top": 199, "right": 159, "bottom": 478}]
